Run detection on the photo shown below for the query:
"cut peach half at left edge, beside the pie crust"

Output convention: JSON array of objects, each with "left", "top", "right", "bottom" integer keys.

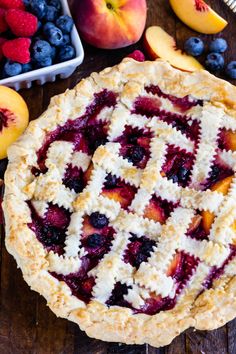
[{"left": 0, "top": 86, "right": 29, "bottom": 159}]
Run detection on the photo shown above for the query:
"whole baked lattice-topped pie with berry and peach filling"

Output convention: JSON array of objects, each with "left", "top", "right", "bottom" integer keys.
[{"left": 3, "top": 59, "right": 236, "bottom": 347}]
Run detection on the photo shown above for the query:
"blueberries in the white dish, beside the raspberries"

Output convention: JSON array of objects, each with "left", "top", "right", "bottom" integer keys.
[{"left": 2, "top": 0, "right": 76, "bottom": 78}]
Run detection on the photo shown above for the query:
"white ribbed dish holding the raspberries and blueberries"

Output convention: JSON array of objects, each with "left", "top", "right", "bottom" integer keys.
[{"left": 0, "top": 0, "right": 84, "bottom": 91}]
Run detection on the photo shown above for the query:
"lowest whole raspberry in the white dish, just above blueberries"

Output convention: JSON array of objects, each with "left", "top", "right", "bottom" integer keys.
[{"left": 2, "top": 38, "right": 31, "bottom": 64}]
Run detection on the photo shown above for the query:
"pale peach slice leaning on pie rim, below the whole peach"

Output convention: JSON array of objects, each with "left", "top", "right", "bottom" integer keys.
[{"left": 144, "top": 26, "right": 203, "bottom": 71}]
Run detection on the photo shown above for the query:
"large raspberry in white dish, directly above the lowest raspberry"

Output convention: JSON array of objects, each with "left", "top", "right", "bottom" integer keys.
[{"left": 6, "top": 9, "right": 38, "bottom": 37}]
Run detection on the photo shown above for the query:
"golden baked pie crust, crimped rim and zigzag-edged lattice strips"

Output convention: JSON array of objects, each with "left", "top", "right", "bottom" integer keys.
[{"left": 3, "top": 59, "right": 236, "bottom": 347}]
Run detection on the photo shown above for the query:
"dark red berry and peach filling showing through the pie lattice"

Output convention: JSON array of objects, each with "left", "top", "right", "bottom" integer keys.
[{"left": 24, "top": 85, "right": 236, "bottom": 315}]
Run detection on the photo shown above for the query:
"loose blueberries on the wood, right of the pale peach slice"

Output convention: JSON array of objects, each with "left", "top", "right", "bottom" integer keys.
[{"left": 184, "top": 37, "right": 236, "bottom": 79}]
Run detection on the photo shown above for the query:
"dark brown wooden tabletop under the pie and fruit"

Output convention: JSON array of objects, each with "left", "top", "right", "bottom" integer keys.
[{"left": 0, "top": 0, "right": 236, "bottom": 354}]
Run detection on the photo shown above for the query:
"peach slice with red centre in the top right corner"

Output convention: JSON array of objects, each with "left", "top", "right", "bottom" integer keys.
[{"left": 170, "top": 0, "right": 228, "bottom": 34}]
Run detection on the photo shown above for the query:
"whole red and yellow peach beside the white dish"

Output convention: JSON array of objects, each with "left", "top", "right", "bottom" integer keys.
[{"left": 73, "top": 0, "right": 147, "bottom": 49}]
